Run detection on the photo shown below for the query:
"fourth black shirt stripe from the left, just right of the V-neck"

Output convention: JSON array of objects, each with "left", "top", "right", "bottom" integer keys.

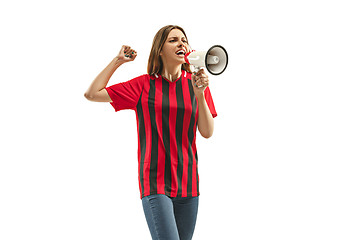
[{"left": 175, "top": 78, "right": 185, "bottom": 197}]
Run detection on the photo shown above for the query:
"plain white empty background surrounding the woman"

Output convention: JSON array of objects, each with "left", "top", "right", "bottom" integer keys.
[{"left": 0, "top": 0, "right": 360, "bottom": 240}]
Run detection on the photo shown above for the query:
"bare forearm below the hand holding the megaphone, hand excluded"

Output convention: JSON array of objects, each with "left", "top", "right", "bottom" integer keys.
[{"left": 197, "top": 96, "right": 214, "bottom": 138}]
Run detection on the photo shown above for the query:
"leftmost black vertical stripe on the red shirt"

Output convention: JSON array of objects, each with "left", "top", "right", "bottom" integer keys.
[{"left": 136, "top": 93, "right": 146, "bottom": 198}]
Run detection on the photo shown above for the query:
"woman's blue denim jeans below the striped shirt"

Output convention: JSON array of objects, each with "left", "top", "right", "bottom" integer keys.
[{"left": 142, "top": 194, "right": 199, "bottom": 240}]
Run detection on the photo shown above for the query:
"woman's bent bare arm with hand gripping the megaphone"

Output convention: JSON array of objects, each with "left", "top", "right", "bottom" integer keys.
[{"left": 192, "top": 69, "right": 214, "bottom": 138}]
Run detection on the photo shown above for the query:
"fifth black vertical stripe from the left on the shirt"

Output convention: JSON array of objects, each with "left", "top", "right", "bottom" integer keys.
[{"left": 187, "top": 79, "right": 197, "bottom": 196}]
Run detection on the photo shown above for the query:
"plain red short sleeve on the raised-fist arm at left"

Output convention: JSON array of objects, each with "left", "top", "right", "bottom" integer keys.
[{"left": 105, "top": 74, "right": 149, "bottom": 112}]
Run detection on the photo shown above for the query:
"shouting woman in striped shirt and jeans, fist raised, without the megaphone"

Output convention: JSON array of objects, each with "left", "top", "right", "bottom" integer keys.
[{"left": 85, "top": 25, "right": 217, "bottom": 240}]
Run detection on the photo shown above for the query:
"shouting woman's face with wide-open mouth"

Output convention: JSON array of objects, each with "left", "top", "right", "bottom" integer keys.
[{"left": 160, "top": 29, "right": 189, "bottom": 64}]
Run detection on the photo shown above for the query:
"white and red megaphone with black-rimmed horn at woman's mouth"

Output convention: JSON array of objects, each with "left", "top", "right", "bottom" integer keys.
[{"left": 184, "top": 45, "right": 228, "bottom": 75}]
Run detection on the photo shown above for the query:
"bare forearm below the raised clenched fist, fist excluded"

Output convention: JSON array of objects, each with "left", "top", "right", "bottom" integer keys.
[{"left": 85, "top": 57, "right": 123, "bottom": 96}]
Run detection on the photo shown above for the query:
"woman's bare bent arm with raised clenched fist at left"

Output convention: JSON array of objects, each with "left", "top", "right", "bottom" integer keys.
[{"left": 84, "top": 46, "right": 137, "bottom": 102}]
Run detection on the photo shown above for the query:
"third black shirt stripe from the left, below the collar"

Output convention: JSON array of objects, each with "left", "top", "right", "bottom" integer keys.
[{"left": 162, "top": 79, "right": 171, "bottom": 194}]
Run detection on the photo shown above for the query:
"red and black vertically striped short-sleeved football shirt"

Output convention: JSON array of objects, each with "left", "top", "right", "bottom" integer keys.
[{"left": 106, "top": 71, "right": 217, "bottom": 198}]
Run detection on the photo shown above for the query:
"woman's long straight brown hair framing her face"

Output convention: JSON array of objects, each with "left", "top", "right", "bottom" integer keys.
[{"left": 148, "top": 25, "right": 191, "bottom": 75}]
